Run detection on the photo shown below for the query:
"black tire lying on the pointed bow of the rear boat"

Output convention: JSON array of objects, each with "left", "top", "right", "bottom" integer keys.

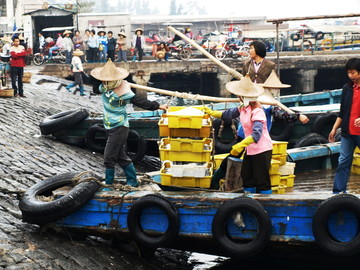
[{"left": 39, "top": 108, "right": 89, "bottom": 135}]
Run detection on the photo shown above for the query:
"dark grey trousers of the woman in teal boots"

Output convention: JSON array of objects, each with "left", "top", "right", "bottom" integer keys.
[{"left": 104, "top": 126, "right": 132, "bottom": 169}]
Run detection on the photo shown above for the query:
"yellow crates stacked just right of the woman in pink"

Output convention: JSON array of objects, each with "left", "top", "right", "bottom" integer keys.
[{"left": 270, "top": 141, "right": 295, "bottom": 194}]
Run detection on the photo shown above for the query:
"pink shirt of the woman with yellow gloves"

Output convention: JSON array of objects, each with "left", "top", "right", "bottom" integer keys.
[{"left": 240, "top": 106, "right": 272, "bottom": 155}]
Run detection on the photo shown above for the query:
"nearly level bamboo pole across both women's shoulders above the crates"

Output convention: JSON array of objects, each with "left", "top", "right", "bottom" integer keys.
[{"left": 129, "top": 83, "right": 278, "bottom": 105}]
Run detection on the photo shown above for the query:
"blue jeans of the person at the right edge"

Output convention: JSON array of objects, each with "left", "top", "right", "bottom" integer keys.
[{"left": 333, "top": 135, "right": 360, "bottom": 193}]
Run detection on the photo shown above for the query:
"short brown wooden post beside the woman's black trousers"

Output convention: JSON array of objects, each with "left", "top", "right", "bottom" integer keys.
[{"left": 225, "top": 157, "right": 243, "bottom": 191}]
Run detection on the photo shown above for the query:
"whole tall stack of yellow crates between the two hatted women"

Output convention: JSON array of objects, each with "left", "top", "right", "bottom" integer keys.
[{"left": 159, "top": 107, "right": 213, "bottom": 188}]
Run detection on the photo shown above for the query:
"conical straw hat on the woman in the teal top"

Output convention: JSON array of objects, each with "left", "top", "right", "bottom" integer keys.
[{"left": 90, "top": 59, "right": 129, "bottom": 82}]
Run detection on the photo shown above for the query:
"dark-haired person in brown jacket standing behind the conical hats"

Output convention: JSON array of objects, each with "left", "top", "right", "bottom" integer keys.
[{"left": 242, "top": 40, "right": 275, "bottom": 83}]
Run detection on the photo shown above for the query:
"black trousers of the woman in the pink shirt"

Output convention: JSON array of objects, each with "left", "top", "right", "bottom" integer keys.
[{"left": 241, "top": 150, "right": 272, "bottom": 192}]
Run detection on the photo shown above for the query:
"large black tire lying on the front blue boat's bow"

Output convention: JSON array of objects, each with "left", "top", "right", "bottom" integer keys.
[{"left": 19, "top": 173, "right": 99, "bottom": 224}]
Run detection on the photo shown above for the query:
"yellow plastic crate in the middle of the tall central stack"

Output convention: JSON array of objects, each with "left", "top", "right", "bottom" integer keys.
[{"left": 159, "top": 138, "right": 213, "bottom": 162}]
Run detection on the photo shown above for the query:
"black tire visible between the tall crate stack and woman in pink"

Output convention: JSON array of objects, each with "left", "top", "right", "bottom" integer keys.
[{"left": 212, "top": 119, "right": 239, "bottom": 154}]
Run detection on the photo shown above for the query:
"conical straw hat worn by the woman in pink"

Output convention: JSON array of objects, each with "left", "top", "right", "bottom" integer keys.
[{"left": 225, "top": 74, "right": 264, "bottom": 97}]
